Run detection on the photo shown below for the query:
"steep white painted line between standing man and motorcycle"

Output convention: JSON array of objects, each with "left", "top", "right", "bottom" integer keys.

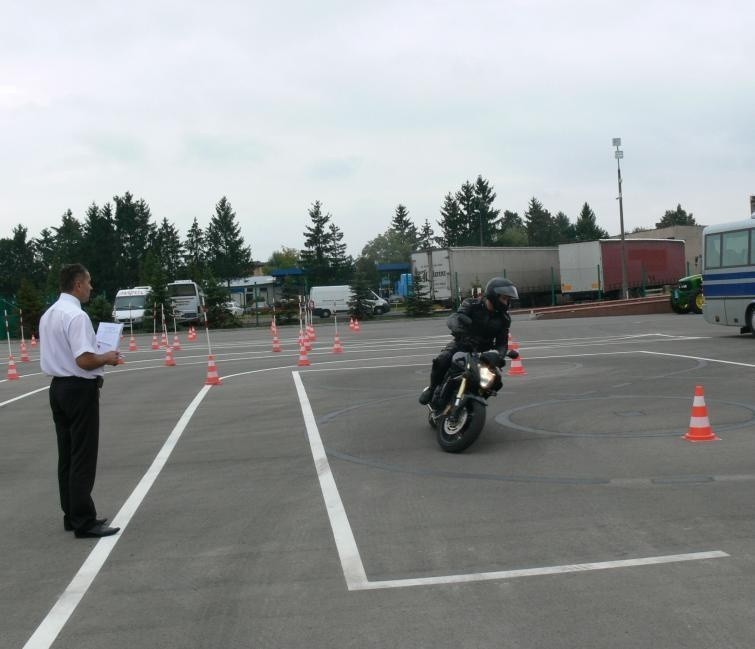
[{"left": 292, "top": 372, "right": 367, "bottom": 590}]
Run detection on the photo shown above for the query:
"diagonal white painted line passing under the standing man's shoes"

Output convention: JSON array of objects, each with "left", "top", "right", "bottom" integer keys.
[{"left": 24, "top": 385, "right": 212, "bottom": 649}]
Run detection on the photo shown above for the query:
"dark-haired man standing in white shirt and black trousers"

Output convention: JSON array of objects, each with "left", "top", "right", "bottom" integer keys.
[{"left": 39, "top": 264, "right": 119, "bottom": 538}]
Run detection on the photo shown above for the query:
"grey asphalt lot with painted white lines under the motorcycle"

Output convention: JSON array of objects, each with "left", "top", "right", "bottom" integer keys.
[{"left": 0, "top": 314, "right": 755, "bottom": 649}]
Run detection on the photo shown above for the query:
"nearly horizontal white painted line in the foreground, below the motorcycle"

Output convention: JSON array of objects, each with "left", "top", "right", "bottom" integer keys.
[{"left": 351, "top": 550, "right": 729, "bottom": 590}]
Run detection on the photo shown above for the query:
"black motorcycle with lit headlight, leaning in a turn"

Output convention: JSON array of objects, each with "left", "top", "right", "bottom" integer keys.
[{"left": 427, "top": 349, "right": 519, "bottom": 453}]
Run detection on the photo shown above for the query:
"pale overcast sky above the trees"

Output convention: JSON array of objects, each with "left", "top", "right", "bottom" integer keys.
[{"left": 0, "top": 0, "right": 755, "bottom": 262}]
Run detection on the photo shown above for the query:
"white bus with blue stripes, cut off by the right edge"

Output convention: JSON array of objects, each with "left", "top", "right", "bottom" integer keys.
[{"left": 703, "top": 212, "right": 755, "bottom": 336}]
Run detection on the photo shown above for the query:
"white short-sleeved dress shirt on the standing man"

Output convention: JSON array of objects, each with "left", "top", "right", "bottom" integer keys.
[{"left": 39, "top": 293, "right": 104, "bottom": 379}]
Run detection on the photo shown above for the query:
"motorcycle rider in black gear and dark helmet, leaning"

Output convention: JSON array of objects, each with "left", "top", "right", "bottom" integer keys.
[{"left": 419, "top": 277, "right": 519, "bottom": 405}]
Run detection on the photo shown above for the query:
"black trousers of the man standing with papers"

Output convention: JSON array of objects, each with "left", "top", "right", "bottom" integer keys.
[{"left": 50, "top": 376, "right": 101, "bottom": 531}]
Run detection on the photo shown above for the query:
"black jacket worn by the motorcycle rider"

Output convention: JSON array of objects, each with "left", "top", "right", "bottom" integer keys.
[{"left": 446, "top": 298, "right": 511, "bottom": 355}]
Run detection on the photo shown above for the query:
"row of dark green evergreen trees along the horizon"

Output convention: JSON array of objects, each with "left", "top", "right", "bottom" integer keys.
[{"left": 0, "top": 176, "right": 695, "bottom": 306}]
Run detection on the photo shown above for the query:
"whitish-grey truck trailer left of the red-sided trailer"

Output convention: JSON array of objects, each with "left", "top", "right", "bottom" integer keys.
[{"left": 412, "top": 246, "right": 561, "bottom": 304}]
